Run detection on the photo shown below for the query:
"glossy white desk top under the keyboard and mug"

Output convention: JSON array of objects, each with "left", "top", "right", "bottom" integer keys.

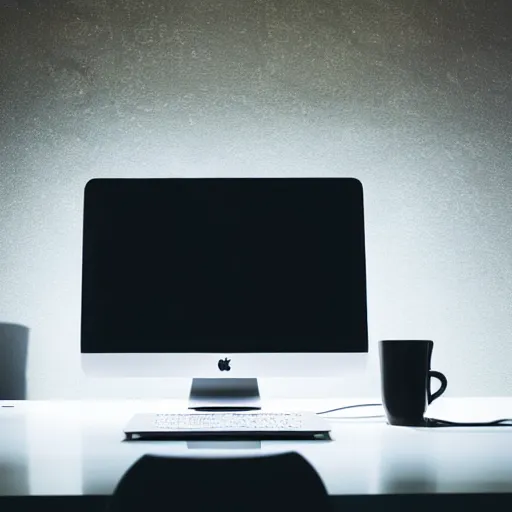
[{"left": 0, "top": 398, "right": 512, "bottom": 496}]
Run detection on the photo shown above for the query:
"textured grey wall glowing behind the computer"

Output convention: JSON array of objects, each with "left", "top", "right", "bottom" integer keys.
[{"left": 0, "top": 0, "right": 512, "bottom": 398}]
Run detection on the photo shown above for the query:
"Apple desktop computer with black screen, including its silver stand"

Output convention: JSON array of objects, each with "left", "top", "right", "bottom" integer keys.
[{"left": 81, "top": 177, "right": 368, "bottom": 409}]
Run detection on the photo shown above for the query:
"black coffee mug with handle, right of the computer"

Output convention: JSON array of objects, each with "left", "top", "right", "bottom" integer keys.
[{"left": 379, "top": 340, "right": 448, "bottom": 427}]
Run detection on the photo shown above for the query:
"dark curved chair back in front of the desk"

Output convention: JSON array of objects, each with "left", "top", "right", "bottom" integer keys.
[{"left": 109, "top": 452, "right": 328, "bottom": 512}]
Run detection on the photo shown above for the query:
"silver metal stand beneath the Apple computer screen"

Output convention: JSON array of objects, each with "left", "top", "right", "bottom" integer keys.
[{"left": 188, "top": 378, "right": 261, "bottom": 411}]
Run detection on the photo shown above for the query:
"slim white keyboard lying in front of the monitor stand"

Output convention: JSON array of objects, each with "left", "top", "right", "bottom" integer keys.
[{"left": 124, "top": 411, "right": 330, "bottom": 439}]
